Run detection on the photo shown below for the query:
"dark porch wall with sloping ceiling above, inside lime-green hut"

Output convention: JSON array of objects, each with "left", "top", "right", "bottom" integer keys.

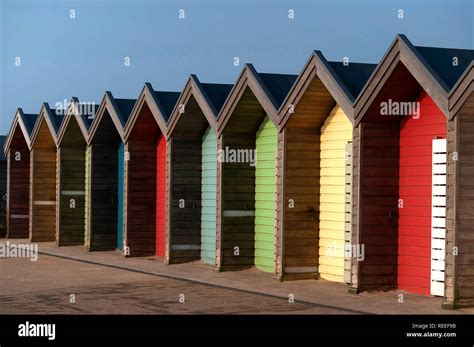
[{"left": 217, "top": 87, "right": 266, "bottom": 270}]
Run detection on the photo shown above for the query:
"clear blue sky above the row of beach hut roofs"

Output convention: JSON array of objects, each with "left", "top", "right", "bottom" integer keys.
[{"left": 0, "top": 0, "right": 474, "bottom": 133}]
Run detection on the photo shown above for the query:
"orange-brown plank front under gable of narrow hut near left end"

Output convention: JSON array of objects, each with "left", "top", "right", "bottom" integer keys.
[{"left": 30, "top": 120, "right": 56, "bottom": 242}]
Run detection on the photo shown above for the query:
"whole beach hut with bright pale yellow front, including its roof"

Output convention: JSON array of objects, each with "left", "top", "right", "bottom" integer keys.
[{"left": 277, "top": 51, "right": 375, "bottom": 283}]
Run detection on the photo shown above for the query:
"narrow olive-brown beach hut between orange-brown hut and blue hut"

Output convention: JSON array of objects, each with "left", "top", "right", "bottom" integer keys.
[{"left": 56, "top": 97, "right": 97, "bottom": 246}]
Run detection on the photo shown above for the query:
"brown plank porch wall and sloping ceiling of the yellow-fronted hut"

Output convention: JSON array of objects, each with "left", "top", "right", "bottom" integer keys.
[{"left": 277, "top": 78, "right": 335, "bottom": 279}]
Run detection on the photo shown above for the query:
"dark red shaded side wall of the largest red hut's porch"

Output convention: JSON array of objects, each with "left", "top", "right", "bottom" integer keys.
[{"left": 353, "top": 121, "right": 400, "bottom": 290}]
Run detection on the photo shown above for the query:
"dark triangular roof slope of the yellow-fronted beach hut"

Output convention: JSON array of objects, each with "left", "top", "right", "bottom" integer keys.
[{"left": 329, "top": 61, "right": 377, "bottom": 102}]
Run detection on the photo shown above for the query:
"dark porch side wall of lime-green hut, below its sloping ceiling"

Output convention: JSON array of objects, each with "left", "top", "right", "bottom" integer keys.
[{"left": 218, "top": 132, "right": 255, "bottom": 269}]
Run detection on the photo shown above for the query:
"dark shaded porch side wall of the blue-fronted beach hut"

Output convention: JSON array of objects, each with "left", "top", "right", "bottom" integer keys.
[{"left": 89, "top": 144, "right": 118, "bottom": 250}]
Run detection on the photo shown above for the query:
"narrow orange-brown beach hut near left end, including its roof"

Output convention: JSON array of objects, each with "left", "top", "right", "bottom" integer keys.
[{"left": 29, "top": 103, "right": 65, "bottom": 242}]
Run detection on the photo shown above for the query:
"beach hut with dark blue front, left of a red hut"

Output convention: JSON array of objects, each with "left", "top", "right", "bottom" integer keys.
[{"left": 86, "top": 91, "right": 136, "bottom": 251}]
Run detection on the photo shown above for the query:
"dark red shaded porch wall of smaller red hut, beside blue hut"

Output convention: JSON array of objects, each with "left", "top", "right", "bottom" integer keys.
[{"left": 124, "top": 140, "right": 157, "bottom": 256}]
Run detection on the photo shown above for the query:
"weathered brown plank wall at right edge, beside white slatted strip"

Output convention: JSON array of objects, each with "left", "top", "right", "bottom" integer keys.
[{"left": 445, "top": 94, "right": 474, "bottom": 307}]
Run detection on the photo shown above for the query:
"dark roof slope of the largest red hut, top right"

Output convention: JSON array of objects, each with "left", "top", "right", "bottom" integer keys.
[{"left": 416, "top": 46, "right": 474, "bottom": 89}]
